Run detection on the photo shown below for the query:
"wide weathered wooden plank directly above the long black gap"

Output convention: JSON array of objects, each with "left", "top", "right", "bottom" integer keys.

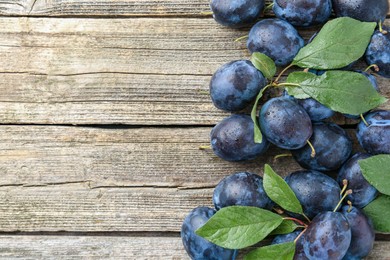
[{"left": 0, "top": 18, "right": 390, "bottom": 125}]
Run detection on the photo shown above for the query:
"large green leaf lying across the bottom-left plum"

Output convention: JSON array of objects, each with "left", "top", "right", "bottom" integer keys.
[{"left": 196, "top": 206, "right": 283, "bottom": 249}]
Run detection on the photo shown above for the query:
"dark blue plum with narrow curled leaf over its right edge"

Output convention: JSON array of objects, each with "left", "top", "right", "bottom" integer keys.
[{"left": 210, "top": 114, "right": 269, "bottom": 161}]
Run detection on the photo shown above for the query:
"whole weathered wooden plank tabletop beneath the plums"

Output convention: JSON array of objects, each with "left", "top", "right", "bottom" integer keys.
[{"left": 0, "top": 0, "right": 390, "bottom": 259}]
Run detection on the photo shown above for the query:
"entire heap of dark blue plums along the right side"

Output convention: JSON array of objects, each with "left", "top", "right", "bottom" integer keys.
[{"left": 181, "top": 0, "right": 390, "bottom": 259}]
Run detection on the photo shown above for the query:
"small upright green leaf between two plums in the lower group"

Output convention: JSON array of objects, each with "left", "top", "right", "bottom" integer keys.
[{"left": 263, "top": 164, "right": 303, "bottom": 214}]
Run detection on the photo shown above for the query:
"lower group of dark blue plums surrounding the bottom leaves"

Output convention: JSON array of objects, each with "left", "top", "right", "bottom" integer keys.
[{"left": 181, "top": 166, "right": 377, "bottom": 259}]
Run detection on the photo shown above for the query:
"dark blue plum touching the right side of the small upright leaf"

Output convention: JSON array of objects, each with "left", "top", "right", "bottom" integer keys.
[{"left": 285, "top": 170, "right": 341, "bottom": 218}]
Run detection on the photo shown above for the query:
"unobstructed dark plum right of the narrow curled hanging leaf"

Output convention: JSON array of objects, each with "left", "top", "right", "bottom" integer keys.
[{"left": 259, "top": 97, "right": 313, "bottom": 150}]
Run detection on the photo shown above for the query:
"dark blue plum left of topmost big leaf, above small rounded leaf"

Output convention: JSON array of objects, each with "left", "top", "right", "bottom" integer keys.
[{"left": 247, "top": 19, "right": 304, "bottom": 66}]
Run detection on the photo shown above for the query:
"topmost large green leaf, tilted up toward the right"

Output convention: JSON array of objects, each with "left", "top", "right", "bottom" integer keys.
[{"left": 292, "top": 17, "right": 376, "bottom": 70}]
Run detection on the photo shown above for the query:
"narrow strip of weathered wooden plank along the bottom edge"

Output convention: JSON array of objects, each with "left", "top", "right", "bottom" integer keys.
[{"left": 0, "top": 235, "right": 390, "bottom": 260}]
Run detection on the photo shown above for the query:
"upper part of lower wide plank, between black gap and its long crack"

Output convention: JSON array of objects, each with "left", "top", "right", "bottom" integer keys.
[{"left": 0, "top": 126, "right": 299, "bottom": 188}]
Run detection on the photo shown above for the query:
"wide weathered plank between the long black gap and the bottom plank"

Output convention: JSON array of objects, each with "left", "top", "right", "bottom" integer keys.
[{"left": 0, "top": 126, "right": 374, "bottom": 232}]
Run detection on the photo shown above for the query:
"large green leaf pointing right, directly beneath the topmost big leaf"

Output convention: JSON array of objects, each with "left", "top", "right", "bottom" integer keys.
[{"left": 287, "top": 70, "right": 387, "bottom": 115}]
